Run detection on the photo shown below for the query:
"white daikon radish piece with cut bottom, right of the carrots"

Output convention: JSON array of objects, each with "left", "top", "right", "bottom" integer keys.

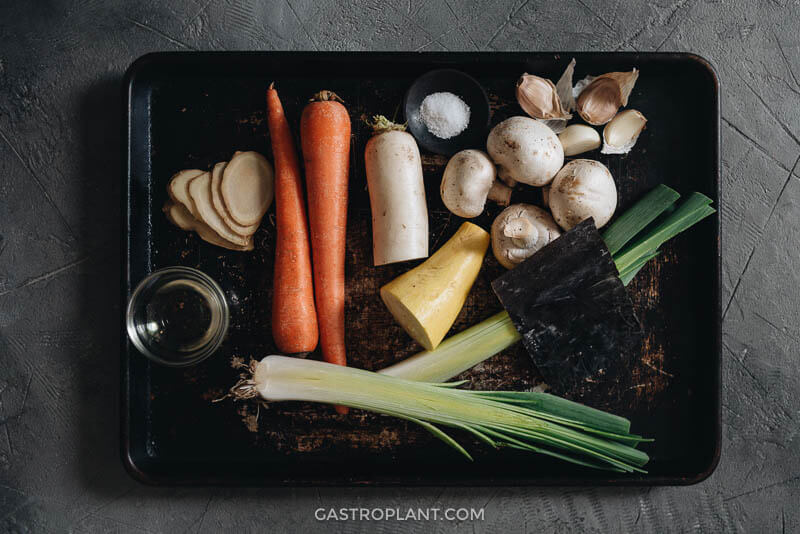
[{"left": 364, "top": 116, "right": 428, "bottom": 265}]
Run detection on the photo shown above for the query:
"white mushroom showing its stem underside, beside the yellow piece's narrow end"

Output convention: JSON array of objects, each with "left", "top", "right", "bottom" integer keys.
[{"left": 492, "top": 204, "right": 561, "bottom": 269}]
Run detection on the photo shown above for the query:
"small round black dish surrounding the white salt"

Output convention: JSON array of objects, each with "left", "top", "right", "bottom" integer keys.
[{"left": 403, "top": 69, "right": 489, "bottom": 156}]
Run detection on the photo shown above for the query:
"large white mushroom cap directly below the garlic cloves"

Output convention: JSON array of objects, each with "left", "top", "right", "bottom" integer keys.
[{"left": 486, "top": 116, "right": 564, "bottom": 186}]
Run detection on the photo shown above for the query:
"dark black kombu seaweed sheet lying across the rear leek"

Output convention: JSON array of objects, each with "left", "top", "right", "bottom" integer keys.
[{"left": 492, "top": 219, "right": 642, "bottom": 404}]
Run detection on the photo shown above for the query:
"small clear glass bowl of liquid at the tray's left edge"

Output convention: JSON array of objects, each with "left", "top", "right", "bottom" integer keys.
[{"left": 125, "top": 267, "right": 230, "bottom": 367}]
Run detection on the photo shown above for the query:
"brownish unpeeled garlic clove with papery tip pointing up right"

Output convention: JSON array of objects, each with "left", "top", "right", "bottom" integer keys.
[{"left": 576, "top": 69, "right": 639, "bottom": 126}]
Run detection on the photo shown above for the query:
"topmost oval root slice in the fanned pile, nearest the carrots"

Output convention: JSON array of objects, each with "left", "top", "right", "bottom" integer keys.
[{"left": 220, "top": 152, "right": 274, "bottom": 226}]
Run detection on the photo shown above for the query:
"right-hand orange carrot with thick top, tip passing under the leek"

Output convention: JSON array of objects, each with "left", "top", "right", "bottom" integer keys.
[{"left": 300, "top": 91, "right": 350, "bottom": 413}]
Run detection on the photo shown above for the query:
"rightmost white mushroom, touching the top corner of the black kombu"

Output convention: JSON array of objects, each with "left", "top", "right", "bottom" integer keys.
[{"left": 548, "top": 159, "right": 617, "bottom": 230}]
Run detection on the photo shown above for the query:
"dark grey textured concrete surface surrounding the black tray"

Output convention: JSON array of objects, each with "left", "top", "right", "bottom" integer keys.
[{"left": 0, "top": 0, "right": 800, "bottom": 533}]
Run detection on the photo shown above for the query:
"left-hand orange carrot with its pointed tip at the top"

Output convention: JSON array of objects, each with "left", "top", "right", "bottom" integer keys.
[{"left": 267, "top": 84, "right": 319, "bottom": 354}]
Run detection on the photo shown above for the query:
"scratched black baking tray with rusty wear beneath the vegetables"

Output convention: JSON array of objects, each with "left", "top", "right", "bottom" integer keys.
[{"left": 122, "top": 53, "right": 720, "bottom": 484}]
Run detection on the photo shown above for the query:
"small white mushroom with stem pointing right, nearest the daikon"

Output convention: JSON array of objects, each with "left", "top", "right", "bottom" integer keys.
[{"left": 439, "top": 150, "right": 511, "bottom": 218}]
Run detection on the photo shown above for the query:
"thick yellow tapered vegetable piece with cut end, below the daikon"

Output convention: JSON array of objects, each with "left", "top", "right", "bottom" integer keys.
[{"left": 381, "top": 222, "right": 489, "bottom": 350}]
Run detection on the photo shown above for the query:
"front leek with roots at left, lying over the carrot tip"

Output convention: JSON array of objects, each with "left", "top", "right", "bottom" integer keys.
[{"left": 230, "top": 356, "right": 649, "bottom": 472}]
